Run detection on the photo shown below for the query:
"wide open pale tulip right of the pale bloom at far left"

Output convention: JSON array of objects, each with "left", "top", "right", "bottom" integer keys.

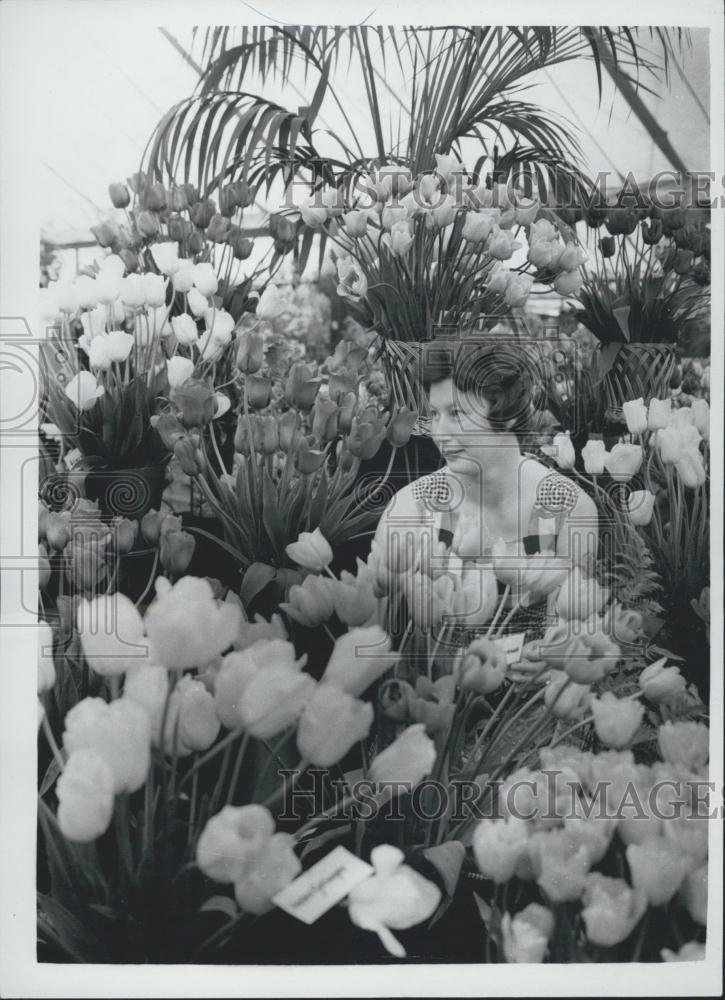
[{"left": 144, "top": 576, "right": 241, "bottom": 670}]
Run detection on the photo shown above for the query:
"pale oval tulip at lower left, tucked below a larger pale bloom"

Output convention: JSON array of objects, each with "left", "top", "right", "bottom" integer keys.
[{"left": 56, "top": 749, "right": 114, "bottom": 843}]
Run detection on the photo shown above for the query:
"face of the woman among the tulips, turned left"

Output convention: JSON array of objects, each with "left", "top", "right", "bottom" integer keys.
[{"left": 429, "top": 378, "right": 496, "bottom": 474}]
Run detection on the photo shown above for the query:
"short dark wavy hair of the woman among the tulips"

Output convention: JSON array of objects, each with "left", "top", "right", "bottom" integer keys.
[{"left": 420, "top": 340, "right": 534, "bottom": 435}]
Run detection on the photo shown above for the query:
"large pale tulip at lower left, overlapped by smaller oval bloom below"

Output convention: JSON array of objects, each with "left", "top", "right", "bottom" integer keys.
[{"left": 63, "top": 698, "right": 151, "bottom": 795}]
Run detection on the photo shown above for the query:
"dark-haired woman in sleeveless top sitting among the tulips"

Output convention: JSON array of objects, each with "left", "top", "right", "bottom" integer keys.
[{"left": 375, "top": 340, "right": 597, "bottom": 641}]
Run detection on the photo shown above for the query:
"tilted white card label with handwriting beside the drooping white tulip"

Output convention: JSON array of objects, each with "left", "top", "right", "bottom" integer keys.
[{"left": 272, "top": 846, "right": 374, "bottom": 924}]
